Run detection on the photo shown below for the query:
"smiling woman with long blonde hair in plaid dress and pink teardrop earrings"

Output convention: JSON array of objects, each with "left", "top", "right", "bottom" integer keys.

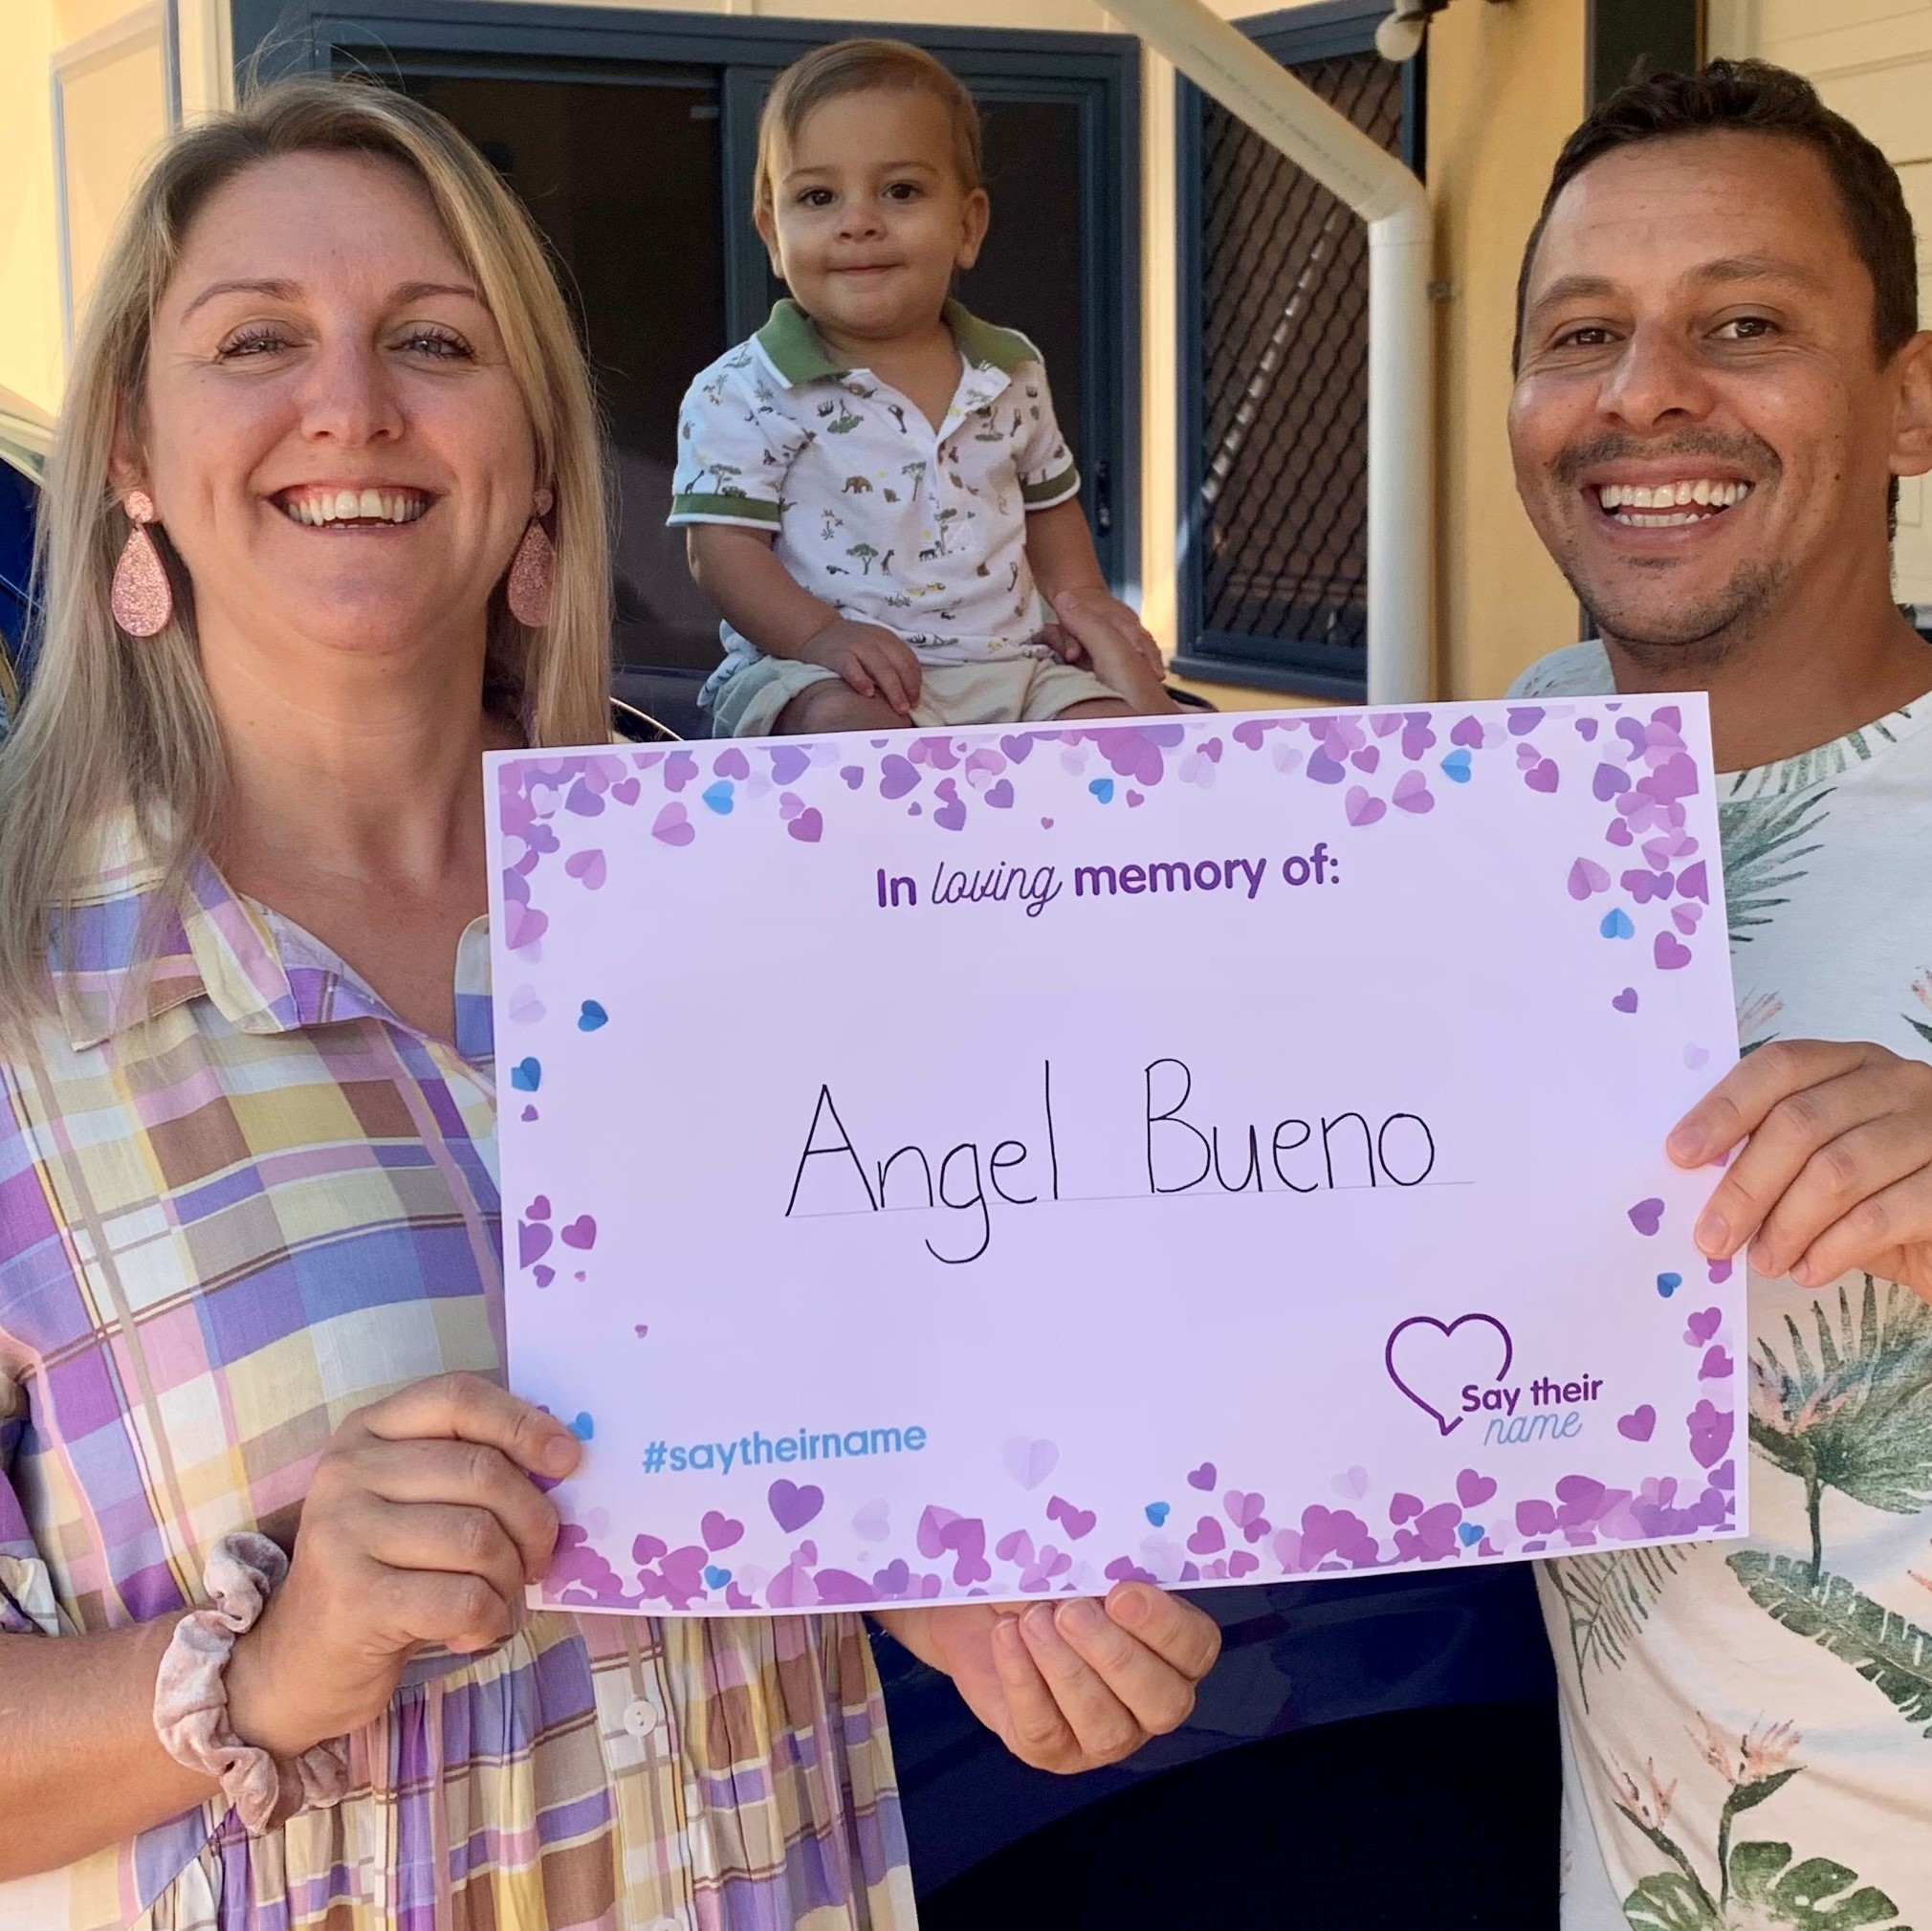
[{"left": 0, "top": 68, "right": 1214, "bottom": 1931}]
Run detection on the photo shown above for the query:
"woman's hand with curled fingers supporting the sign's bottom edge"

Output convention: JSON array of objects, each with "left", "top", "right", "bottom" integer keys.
[{"left": 879, "top": 1582, "right": 1221, "bottom": 1772}]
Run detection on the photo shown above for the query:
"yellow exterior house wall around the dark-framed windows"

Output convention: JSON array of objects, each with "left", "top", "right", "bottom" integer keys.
[{"left": 0, "top": 0, "right": 1584, "bottom": 707}]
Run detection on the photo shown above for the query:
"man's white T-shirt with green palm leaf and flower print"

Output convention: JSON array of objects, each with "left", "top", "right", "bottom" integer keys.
[{"left": 1513, "top": 643, "right": 1932, "bottom": 1931}]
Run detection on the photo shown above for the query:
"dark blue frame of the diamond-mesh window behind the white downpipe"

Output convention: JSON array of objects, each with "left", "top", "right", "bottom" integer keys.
[{"left": 1175, "top": 0, "right": 1428, "bottom": 701}]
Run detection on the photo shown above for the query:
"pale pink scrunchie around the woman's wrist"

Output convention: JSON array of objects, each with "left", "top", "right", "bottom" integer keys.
[{"left": 155, "top": 1529, "right": 350, "bottom": 1836}]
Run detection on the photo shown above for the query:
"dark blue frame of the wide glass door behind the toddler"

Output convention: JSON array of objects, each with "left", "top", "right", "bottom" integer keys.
[{"left": 230, "top": 0, "right": 1142, "bottom": 595}]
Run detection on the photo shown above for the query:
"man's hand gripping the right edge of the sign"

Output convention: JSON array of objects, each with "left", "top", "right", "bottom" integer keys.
[{"left": 1667, "top": 1039, "right": 1932, "bottom": 1300}]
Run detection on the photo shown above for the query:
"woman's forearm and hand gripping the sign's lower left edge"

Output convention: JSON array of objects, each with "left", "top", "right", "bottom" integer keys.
[{"left": 0, "top": 1375, "right": 580, "bottom": 1876}]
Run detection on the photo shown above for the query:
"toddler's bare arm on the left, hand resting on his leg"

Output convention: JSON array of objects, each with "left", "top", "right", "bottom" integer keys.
[{"left": 684, "top": 523, "right": 920, "bottom": 716}]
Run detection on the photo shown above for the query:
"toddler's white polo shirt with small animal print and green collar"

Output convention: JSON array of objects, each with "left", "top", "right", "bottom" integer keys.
[{"left": 670, "top": 301, "right": 1080, "bottom": 688}]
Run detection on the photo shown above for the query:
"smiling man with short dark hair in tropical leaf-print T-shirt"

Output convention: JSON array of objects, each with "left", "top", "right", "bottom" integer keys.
[{"left": 1509, "top": 62, "right": 1932, "bottom": 1931}]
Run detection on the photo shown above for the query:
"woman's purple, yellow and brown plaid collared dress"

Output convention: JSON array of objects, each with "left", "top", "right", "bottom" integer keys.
[{"left": 0, "top": 826, "right": 913, "bottom": 1931}]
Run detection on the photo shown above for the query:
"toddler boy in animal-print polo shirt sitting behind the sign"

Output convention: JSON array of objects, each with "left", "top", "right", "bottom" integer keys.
[{"left": 670, "top": 40, "right": 1173, "bottom": 737}]
